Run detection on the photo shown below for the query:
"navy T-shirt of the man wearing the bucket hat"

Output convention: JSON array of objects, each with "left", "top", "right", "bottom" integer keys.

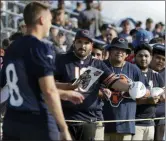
[{"left": 103, "top": 60, "right": 145, "bottom": 134}]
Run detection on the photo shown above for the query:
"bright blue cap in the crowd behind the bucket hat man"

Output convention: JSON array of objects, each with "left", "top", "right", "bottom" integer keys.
[{"left": 132, "top": 29, "right": 151, "bottom": 47}]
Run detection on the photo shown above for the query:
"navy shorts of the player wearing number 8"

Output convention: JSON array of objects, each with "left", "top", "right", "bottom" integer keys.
[{"left": 2, "top": 110, "right": 60, "bottom": 141}]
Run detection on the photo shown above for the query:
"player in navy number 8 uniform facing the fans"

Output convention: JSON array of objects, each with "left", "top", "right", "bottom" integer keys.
[{"left": 1, "top": 2, "right": 83, "bottom": 140}]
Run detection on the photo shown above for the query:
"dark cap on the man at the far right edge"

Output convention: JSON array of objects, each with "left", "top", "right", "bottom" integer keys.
[{"left": 153, "top": 44, "right": 165, "bottom": 56}]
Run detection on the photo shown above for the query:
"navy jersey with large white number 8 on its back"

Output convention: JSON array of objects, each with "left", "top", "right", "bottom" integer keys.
[{"left": 1, "top": 35, "right": 58, "bottom": 140}]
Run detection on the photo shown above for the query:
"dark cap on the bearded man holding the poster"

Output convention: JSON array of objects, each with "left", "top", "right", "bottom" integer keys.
[{"left": 75, "top": 30, "right": 93, "bottom": 42}]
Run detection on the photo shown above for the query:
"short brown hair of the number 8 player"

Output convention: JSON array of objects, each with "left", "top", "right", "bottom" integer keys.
[{"left": 23, "top": 2, "right": 49, "bottom": 26}]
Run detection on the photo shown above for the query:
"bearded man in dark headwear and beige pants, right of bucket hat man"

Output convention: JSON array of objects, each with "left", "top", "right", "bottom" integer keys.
[{"left": 132, "top": 43, "right": 164, "bottom": 141}]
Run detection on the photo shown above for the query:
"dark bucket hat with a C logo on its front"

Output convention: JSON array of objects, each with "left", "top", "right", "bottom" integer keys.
[{"left": 106, "top": 37, "right": 131, "bottom": 54}]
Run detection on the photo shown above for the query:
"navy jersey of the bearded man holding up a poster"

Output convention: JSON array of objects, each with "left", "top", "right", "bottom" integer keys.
[{"left": 55, "top": 52, "right": 111, "bottom": 121}]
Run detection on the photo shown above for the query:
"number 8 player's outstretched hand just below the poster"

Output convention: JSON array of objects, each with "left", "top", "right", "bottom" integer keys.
[{"left": 63, "top": 90, "right": 84, "bottom": 104}]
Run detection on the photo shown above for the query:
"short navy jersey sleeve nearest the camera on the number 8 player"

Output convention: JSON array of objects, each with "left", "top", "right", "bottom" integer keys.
[{"left": 29, "top": 42, "right": 55, "bottom": 78}]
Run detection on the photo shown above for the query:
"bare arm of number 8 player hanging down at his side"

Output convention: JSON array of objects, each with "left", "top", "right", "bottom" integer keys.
[{"left": 39, "top": 76, "right": 68, "bottom": 132}]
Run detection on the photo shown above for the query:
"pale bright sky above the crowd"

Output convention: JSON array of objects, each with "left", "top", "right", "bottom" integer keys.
[{"left": 102, "top": 1, "right": 165, "bottom": 23}]
